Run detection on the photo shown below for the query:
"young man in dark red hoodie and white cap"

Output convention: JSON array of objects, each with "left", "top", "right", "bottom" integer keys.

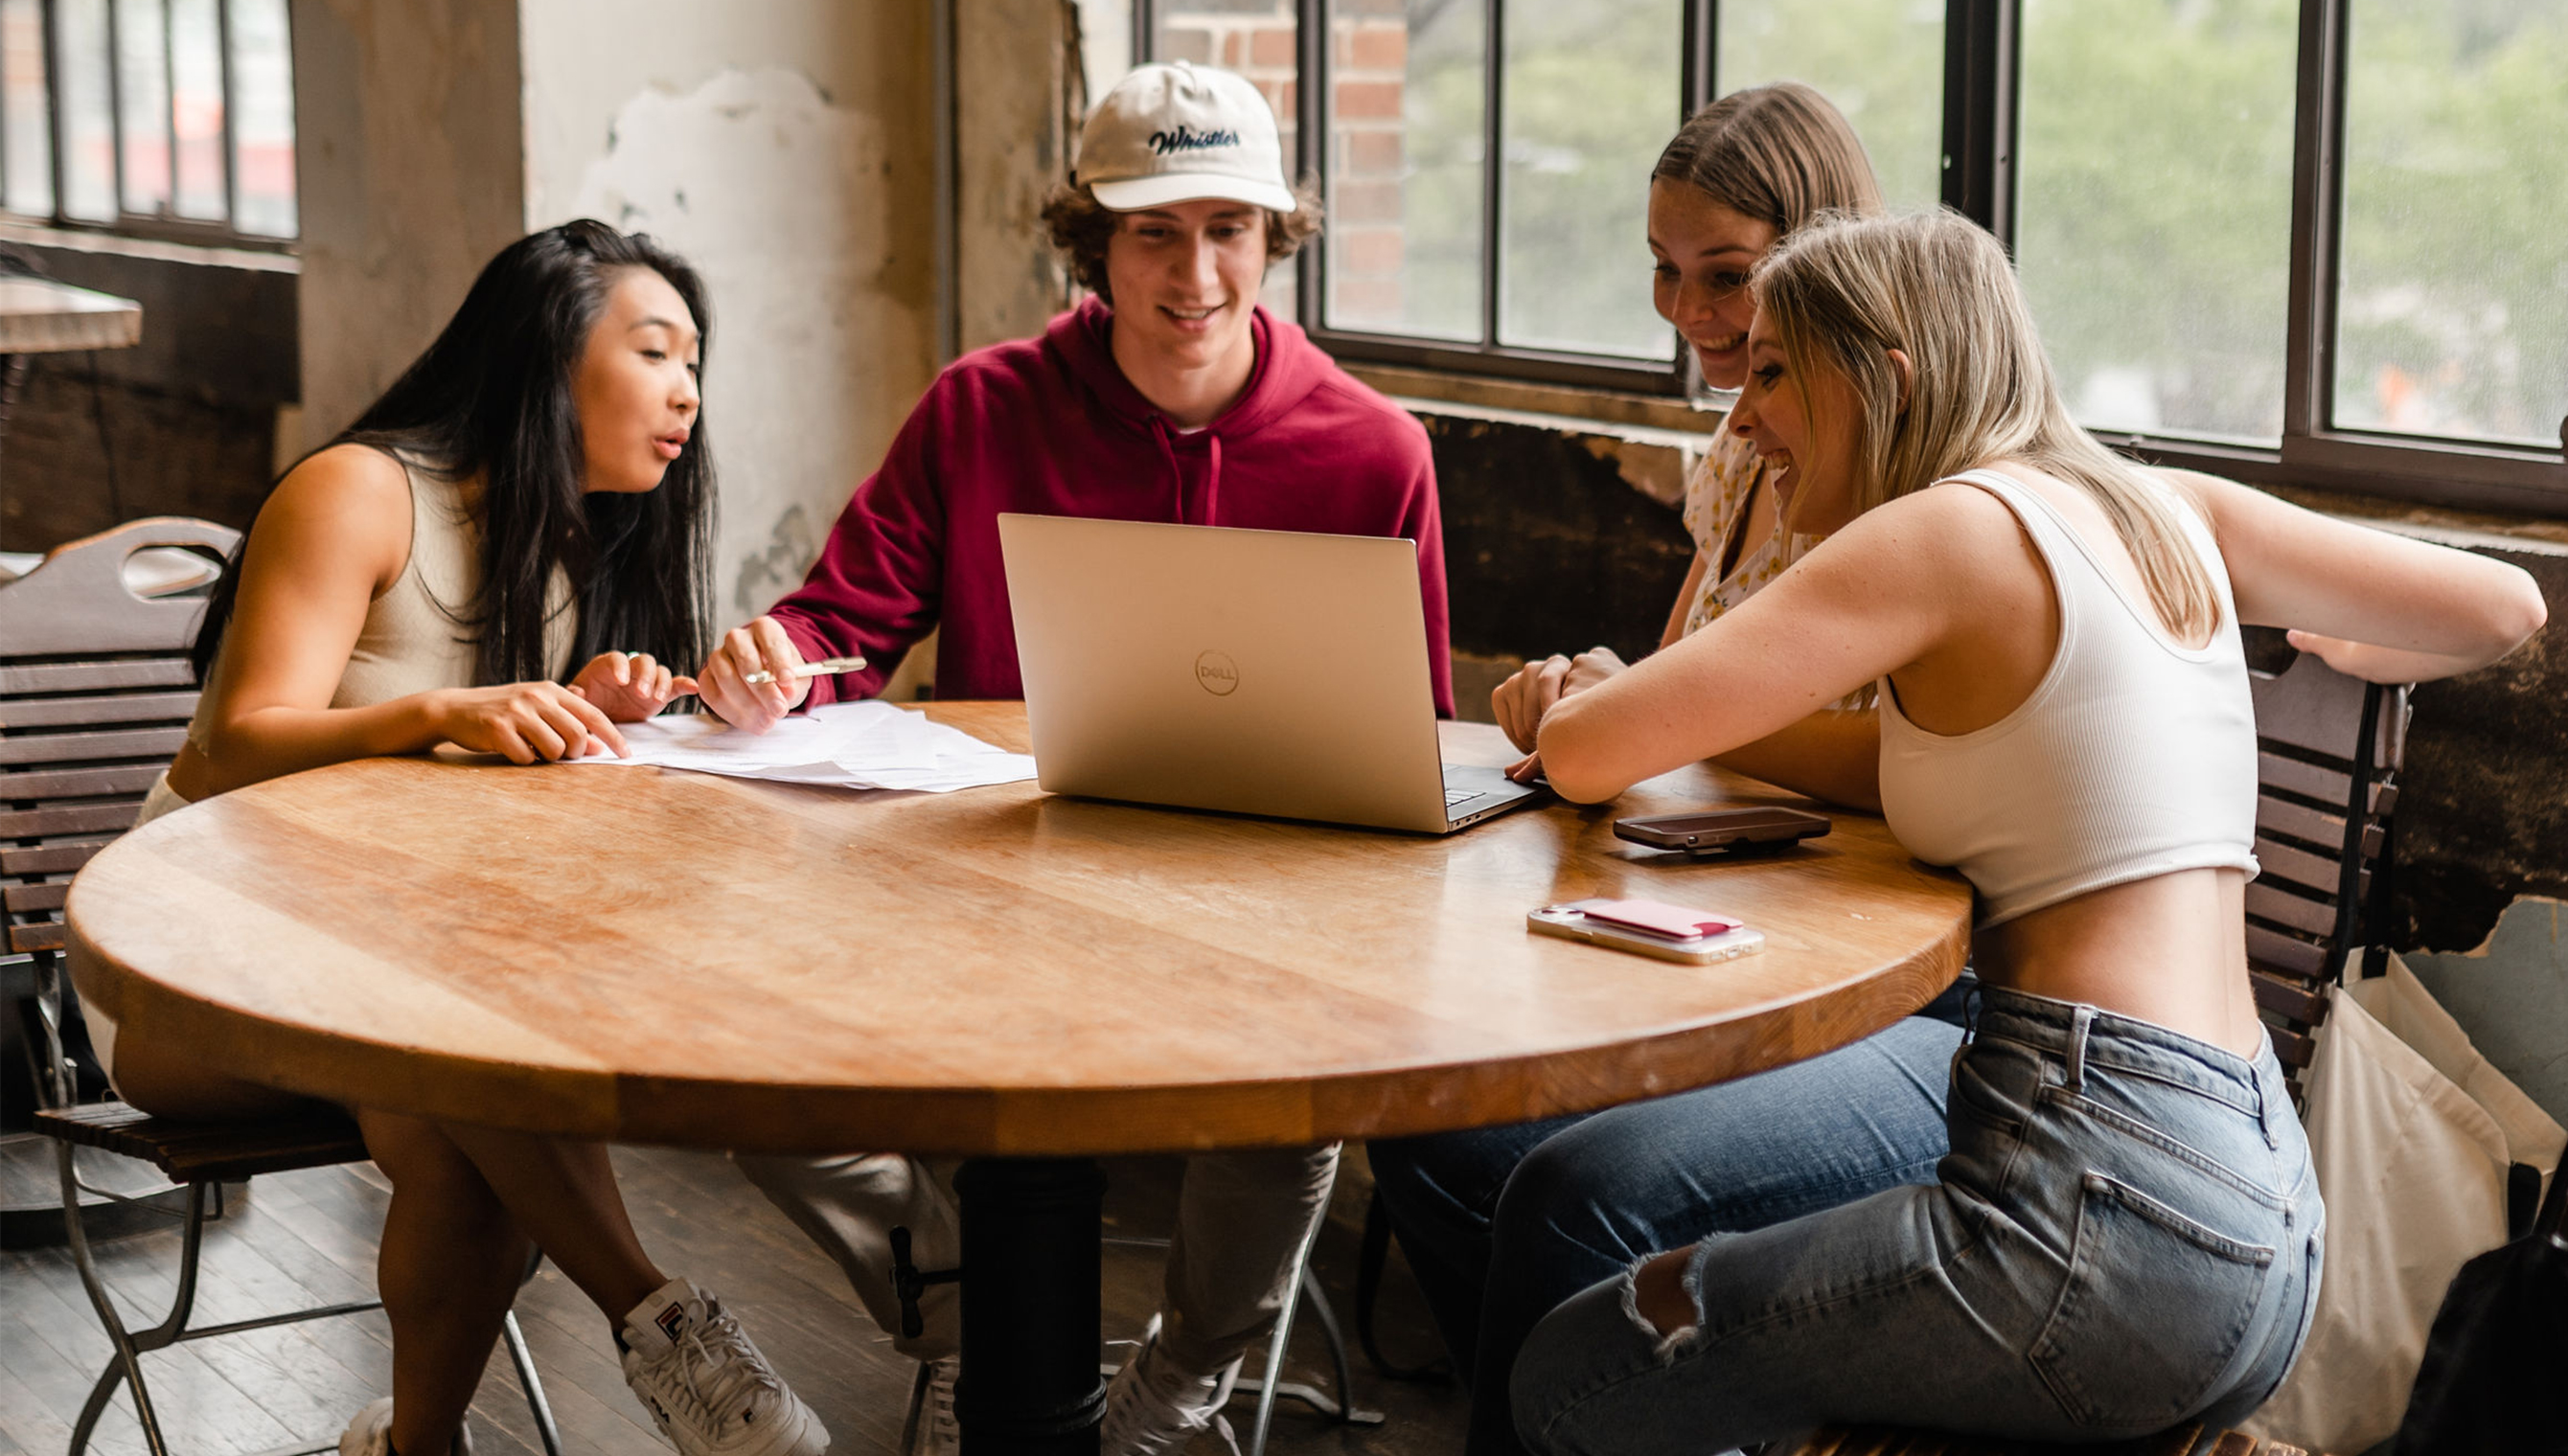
[{"left": 699, "top": 61, "right": 1454, "bottom": 1456}]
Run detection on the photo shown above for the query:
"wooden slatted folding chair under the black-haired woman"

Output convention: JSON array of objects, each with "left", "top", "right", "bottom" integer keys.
[{"left": 0, "top": 519, "right": 560, "bottom": 1456}]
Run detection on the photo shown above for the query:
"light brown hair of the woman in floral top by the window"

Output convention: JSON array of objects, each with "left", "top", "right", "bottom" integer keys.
[{"left": 1649, "top": 82, "right": 1882, "bottom": 237}]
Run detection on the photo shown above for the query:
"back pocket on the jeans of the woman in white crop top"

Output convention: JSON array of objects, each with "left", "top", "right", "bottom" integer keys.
[{"left": 2029, "top": 1171, "right": 2275, "bottom": 1433}]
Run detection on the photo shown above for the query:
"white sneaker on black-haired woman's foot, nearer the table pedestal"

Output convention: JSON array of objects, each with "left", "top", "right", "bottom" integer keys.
[{"left": 619, "top": 1279, "right": 830, "bottom": 1456}]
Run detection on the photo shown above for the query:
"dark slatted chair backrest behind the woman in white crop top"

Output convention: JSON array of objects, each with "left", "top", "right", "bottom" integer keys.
[{"left": 2247, "top": 652, "right": 2409, "bottom": 1091}]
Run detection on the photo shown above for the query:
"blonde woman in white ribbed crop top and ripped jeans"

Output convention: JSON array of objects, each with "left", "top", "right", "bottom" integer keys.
[{"left": 1515, "top": 216, "right": 2545, "bottom": 1453}]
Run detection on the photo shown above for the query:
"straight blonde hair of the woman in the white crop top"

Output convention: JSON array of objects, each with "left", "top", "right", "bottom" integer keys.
[{"left": 1752, "top": 211, "right": 2219, "bottom": 642}]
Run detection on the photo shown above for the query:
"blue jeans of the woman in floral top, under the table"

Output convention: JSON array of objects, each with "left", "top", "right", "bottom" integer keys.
[{"left": 1368, "top": 984, "right": 1967, "bottom": 1456}]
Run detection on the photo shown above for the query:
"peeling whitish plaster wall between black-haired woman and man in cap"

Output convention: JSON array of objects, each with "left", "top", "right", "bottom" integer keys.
[{"left": 521, "top": 0, "right": 937, "bottom": 624}]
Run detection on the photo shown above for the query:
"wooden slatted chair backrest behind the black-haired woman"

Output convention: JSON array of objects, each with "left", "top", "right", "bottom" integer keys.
[{"left": 0, "top": 519, "right": 241, "bottom": 955}]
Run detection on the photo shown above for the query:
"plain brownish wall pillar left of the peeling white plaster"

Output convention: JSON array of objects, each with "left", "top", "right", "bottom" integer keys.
[{"left": 280, "top": 0, "right": 526, "bottom": 457}]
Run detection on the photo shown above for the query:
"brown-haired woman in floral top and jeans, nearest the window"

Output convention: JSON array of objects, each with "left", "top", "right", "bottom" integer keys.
[{"left": 1371, "top": 82, "right": 1962, "bottom": 1456}]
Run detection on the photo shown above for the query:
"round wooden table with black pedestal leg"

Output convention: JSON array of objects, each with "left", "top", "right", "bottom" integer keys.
[{"left": 67, "top": 704, "right": 1970, "bottom": 1451}]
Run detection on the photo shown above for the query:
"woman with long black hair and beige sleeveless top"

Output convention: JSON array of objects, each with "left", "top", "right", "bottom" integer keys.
[{"left": 87, "top": 221, "right": 830, "bottom": 1456}]
